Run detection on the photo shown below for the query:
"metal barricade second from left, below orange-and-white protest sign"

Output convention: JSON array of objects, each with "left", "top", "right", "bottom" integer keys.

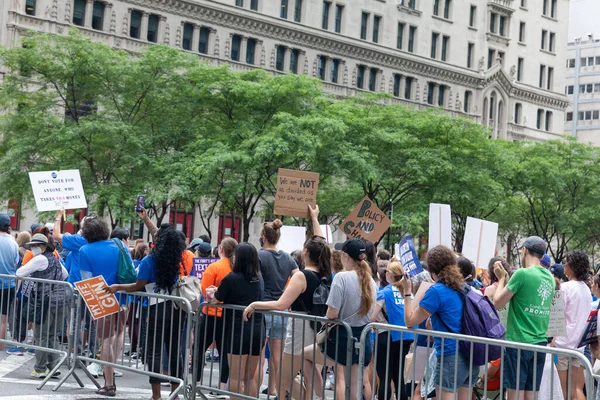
[{"left": 54, "top": 292, "right": 195, "bottom": 400}]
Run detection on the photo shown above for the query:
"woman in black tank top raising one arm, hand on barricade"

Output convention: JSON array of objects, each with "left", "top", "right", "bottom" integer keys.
[{"left": 244, "top": 205, "right": 331, "bottom": 399}]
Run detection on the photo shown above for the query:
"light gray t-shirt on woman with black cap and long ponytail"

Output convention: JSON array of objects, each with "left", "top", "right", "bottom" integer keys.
[{"left": 327, "top": 271, "right": 377, "bottom": 326}]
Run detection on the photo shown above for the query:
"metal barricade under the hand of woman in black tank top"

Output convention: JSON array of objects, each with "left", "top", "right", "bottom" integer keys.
[{"left": 191, "top": 303, "right": 358, "bottom": 400}]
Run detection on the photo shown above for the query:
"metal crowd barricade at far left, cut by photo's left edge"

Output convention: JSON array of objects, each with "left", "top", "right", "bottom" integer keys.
[{"left": 0, "top": 275, "right": 74, "bottom": 390}]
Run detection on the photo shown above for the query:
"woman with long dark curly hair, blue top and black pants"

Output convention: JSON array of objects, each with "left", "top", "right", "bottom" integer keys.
[{"left": 105, "top": 224, "right": 186, "bottom": 400}]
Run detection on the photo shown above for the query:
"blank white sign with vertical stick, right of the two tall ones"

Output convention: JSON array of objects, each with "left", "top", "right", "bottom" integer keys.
[{"left": 463, "top": 217, "right": 498, "bottom": 274}]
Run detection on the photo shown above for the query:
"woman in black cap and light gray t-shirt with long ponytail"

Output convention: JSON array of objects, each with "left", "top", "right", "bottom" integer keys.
[{"left": 304, "top": 239, "right": 377, "bottom": 400}]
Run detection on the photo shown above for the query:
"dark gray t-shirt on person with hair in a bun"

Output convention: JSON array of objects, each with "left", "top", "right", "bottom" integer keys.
[{"left": 258, "top": 250, "right": 298, "bottom": 301}]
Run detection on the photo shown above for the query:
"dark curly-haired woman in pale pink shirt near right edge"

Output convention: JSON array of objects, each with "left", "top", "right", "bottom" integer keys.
[{"left": 553, "top": 250, "right": 592, "bottom": 400}]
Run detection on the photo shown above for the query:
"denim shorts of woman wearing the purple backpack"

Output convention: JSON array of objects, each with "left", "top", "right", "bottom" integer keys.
[{"left": 434, "top": 351, "right": 479, "bottom": 392}]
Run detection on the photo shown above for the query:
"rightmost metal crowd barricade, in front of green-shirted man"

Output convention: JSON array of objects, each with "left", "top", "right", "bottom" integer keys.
[{"left": 353, "top": 323, "right": 600, "bottom": 400}]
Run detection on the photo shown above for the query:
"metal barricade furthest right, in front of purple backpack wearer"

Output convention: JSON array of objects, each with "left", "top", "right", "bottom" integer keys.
[{"left": 352, "top": 323, "right": 600, "bottom": 400}]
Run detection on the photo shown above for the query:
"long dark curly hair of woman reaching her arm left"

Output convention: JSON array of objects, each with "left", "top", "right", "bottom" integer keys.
[{"left": 152, "top": 224, "right": 185, "bottom": 290}]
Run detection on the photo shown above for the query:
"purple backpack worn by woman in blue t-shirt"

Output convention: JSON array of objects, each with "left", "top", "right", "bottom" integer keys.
[{"left": 459, "top": 287, "right": 506, "bottom": 365}]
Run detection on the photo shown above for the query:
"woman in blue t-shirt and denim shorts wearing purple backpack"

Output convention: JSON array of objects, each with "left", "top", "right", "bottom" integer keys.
[{"left": 402, "top": 246, "right": 479, "bottom": 400}]
